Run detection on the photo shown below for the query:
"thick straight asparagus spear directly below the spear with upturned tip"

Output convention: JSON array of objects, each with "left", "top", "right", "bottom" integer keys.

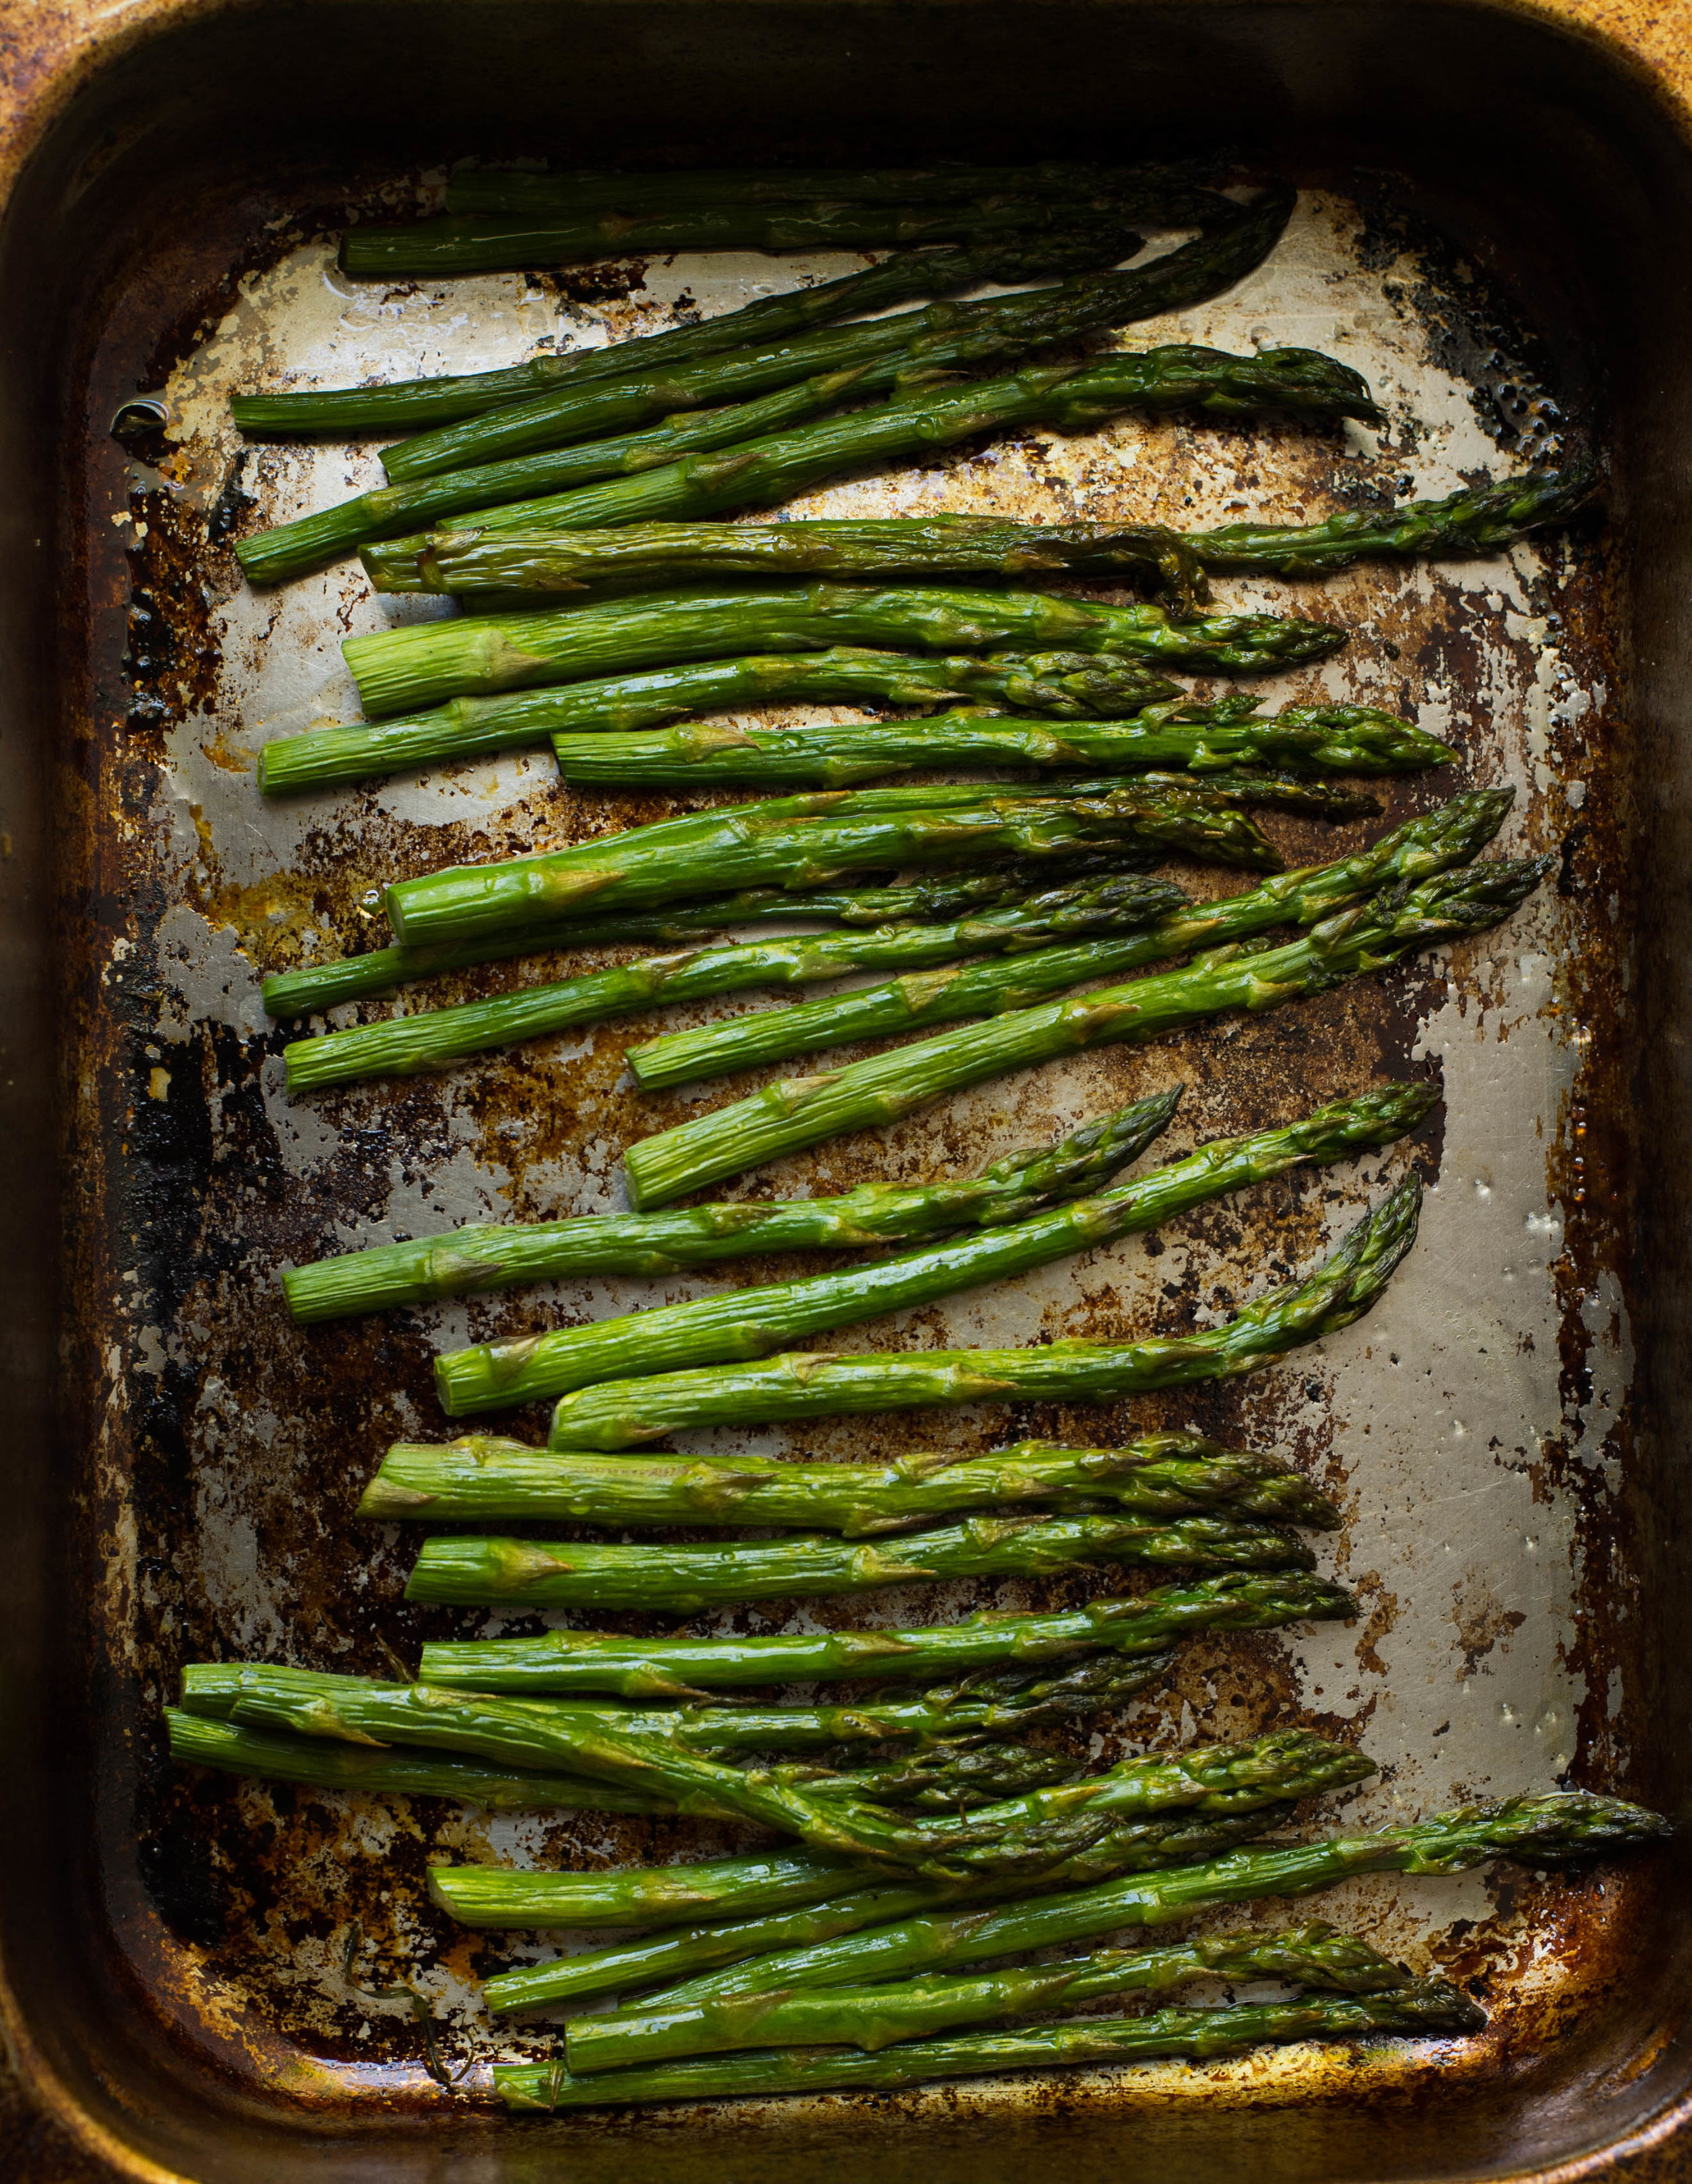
[{"left": 358, "top": 1433, "right": 1338, "bottom": 1540}]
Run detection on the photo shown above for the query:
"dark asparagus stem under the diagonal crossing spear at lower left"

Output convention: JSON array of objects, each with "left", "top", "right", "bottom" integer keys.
[{"left": 164, "top": 1706, "right": 675, "bottom": 1812}]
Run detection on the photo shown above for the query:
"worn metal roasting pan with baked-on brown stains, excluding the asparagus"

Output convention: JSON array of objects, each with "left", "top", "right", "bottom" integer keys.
[{"left": 0, "top": 4, "right": 1692, "bottom": 2184}]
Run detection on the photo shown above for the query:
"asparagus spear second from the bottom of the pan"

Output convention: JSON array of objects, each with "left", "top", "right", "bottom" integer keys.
[{"left": 563, "top": 1924, "right": 1410, "bottom": 2077}]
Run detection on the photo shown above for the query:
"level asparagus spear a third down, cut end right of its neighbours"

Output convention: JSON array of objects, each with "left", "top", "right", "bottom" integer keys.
[{"left": 550, "top": 696, "right": 1452, "bottom": 788}]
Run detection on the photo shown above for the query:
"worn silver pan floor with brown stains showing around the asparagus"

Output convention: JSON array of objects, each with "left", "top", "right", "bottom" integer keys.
[{"left": 94, "top": 192, "right": 1635, "bottom": 2120}]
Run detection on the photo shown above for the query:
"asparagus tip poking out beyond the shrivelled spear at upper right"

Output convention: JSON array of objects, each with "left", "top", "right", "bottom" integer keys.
[{"left": 1186, "top": 456, "right": 1601, "bottom": 577}]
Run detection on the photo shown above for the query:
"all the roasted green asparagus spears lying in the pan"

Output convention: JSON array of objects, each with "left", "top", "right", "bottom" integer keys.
[{"left": 155, "top": 164, "right": 1641, "bottom": 2110}]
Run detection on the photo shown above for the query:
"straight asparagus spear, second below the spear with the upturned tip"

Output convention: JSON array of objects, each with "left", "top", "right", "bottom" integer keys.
[{"left": 406, "top": 1511, "right": 1312, "bottom": 1614}]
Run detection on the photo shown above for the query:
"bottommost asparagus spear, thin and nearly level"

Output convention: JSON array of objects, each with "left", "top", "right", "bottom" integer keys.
[{"left": 493, "top": 1979, "right": 1485, "bottom": 2112}]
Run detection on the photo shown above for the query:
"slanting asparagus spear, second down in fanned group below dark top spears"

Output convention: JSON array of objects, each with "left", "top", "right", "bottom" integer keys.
[{"left": 393, "top": 223, "right": 1310, "bottom": 483}]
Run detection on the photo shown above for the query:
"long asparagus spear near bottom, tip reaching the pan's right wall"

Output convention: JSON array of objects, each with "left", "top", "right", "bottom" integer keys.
[{"left": 661, "top": 1791, "right": 1672, "bottom": 2003}]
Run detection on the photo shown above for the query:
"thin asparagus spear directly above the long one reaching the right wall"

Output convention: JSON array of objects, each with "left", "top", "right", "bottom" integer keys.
[{"left": 483, "top": 1804, "right": 1293, "bottom": 2013}]
